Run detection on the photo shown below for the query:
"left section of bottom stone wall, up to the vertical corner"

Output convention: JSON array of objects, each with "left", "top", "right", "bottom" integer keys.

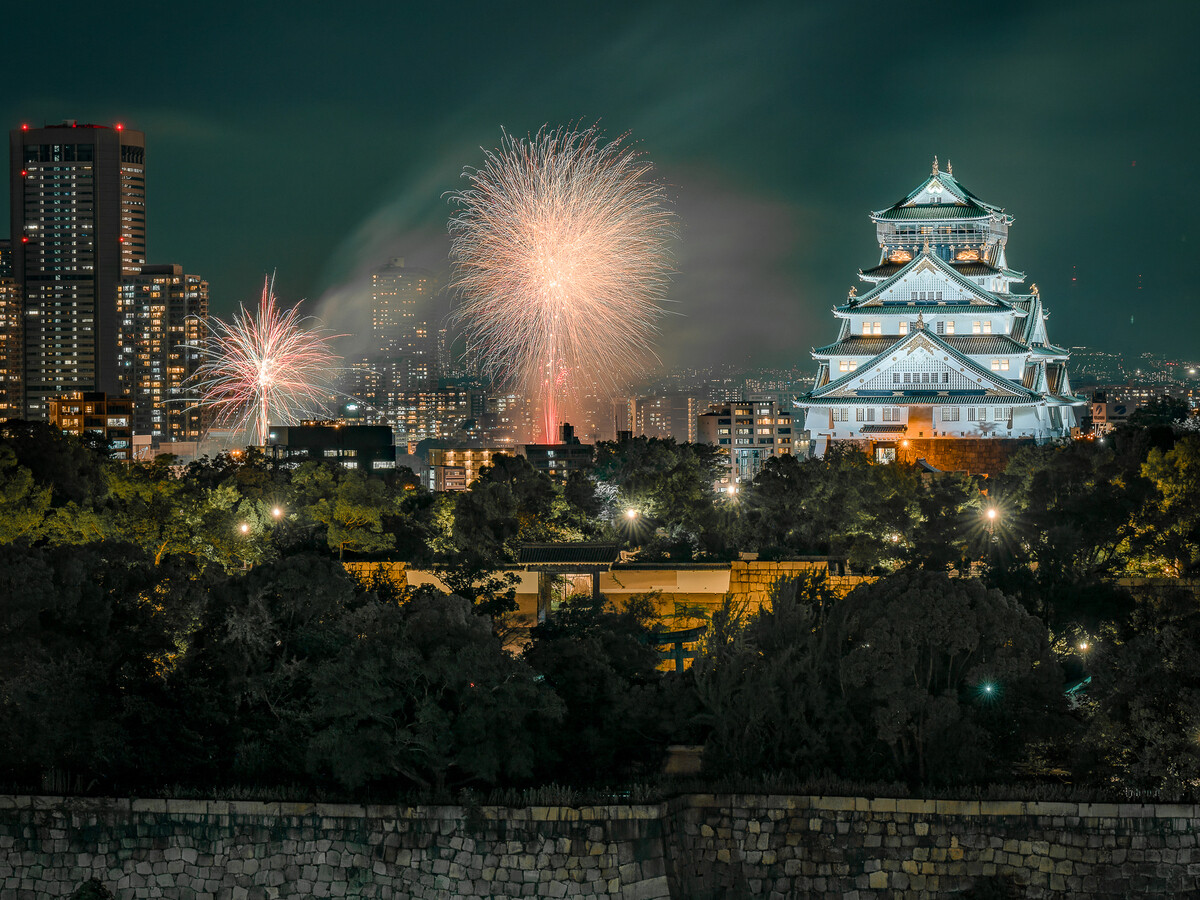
[{"left": 0, "top": 797, "right": 670, "bottom": 900}]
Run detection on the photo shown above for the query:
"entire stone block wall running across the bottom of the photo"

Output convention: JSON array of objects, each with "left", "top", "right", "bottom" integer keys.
[{"left": 0, "top": 794, "right": 1200, "bottom": 900}]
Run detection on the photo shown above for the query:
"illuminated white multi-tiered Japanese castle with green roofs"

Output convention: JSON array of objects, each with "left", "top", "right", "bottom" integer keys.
[{"left": 796, "top": 157, "right": 1086, "bottom": 472}]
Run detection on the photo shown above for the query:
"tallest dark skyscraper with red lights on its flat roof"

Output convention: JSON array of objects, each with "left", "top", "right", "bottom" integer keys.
[{"left": 10, "top": 121, "right": 146, "bottom": 419}]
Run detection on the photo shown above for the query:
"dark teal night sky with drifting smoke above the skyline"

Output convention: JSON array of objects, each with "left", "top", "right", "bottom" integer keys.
[{"left": 0, "top": 0, "right": 1200, "bottom": 367}]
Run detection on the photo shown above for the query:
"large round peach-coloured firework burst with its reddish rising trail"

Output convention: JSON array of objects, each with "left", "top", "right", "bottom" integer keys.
[{"left": 449, "top": 127, "right": 674, "bottom": 442}]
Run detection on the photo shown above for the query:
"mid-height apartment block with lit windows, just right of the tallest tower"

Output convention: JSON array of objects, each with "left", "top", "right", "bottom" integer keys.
[{"left": 116, "top": 265, "right": 209, "bottom": 442}]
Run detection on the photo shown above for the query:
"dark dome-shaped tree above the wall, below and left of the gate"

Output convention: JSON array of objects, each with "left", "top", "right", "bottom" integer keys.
[{"left": 307, "top": 593, "right": 562, "bottom": 788}]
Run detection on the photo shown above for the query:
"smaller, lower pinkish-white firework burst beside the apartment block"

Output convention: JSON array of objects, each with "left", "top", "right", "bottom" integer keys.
[{"left": 190, "top": 278, "right": 338, "bottom": 446}]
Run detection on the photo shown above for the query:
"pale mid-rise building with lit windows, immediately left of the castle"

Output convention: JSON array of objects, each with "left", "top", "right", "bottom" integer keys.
[{"left": 696, "top": 400, "right": 808, "bottom": 481}]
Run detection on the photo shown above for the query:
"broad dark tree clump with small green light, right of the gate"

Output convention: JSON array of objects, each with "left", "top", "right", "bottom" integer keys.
[{"left": 697, "top": 570, "right": 1063, "bottom": 782}]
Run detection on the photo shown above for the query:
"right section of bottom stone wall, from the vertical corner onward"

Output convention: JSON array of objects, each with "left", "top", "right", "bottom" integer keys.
[{"left": 664, "top": 794, "right": 1200, "bottom": 900}]
